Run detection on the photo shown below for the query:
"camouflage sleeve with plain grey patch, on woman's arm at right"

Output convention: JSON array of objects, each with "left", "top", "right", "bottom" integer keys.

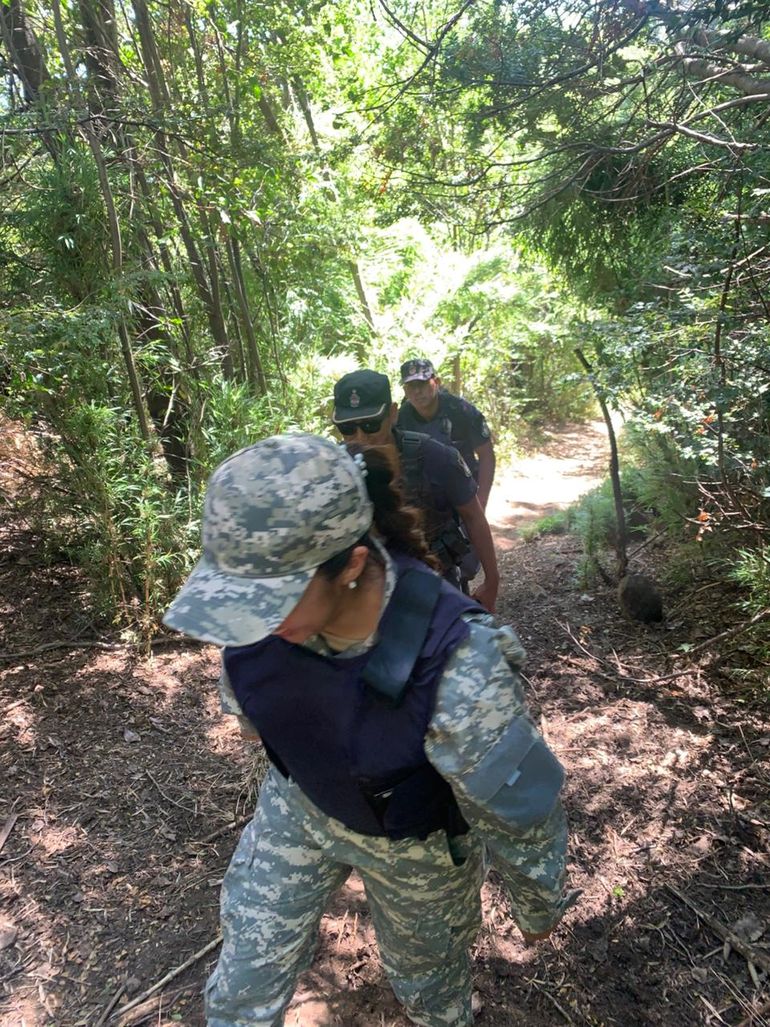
[{"left": 425, "top": 614, "right": 572, "bottom": 934}]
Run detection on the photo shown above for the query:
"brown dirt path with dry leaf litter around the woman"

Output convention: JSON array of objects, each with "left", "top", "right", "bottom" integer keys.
[{"left": 0, "top": 426, "right": 770, "bottom": 1027}]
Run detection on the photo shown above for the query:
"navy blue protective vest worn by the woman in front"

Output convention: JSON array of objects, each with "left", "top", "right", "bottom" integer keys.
[{"left": 224, "top": 554, "right": 478, "bottom": 839}]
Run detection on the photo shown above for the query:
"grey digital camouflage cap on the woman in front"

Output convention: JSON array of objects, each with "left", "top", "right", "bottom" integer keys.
[{"left": 163, "top": 434, "right": 372, "bottom": 645}]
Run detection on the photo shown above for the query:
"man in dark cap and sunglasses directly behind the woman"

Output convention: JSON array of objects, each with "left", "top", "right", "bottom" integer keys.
[{"left": 333, "top": 369, "right": 500, "bottom": 613}]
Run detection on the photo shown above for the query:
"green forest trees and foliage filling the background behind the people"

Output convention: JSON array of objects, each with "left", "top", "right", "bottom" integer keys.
[{"left": 0, "top": 0, "right": 770, "bottom": 644}]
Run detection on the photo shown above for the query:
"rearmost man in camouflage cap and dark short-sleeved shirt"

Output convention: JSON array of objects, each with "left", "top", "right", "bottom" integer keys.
[{"left": 398, "top": 358, "right": 495, "bottom": 509}]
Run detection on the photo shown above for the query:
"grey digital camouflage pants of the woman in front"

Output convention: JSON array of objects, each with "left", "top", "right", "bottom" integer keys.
[{"left": 206, "top": 770, "right": 483, "bottom": 1027}]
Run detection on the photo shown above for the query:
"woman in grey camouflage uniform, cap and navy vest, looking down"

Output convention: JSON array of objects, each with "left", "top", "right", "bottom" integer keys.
[{"left": 165, "top": 435, "right": 571, "bottom": 1027}]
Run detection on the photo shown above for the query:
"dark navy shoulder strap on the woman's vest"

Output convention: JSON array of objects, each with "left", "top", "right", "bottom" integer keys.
[{"left": 362, "top": 569, "right": 441, "bottom": 707}]
